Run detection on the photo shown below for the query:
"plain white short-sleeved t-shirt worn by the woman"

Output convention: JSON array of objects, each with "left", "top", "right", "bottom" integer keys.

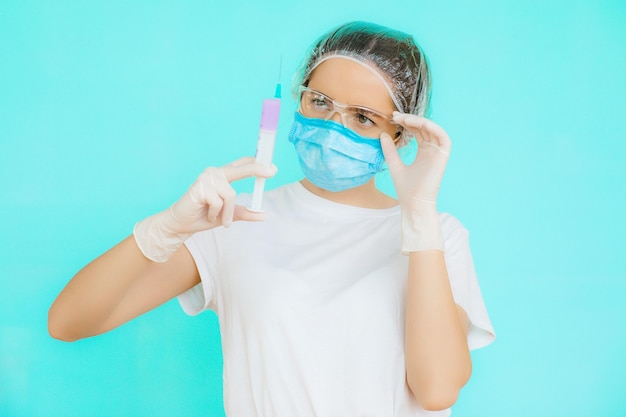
[{"left": 179, "top": 183, "right": 494, "bottom": 417}]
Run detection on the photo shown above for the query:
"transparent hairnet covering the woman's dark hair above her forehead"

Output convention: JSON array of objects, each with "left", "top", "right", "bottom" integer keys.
[{"left": 293, "top": 22, "right": 430, "bottom": 121}]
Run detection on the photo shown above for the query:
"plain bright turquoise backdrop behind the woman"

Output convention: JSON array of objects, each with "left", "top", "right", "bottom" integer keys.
[{"left": 0, "top": 0, "right": 626, "bottom": 417}]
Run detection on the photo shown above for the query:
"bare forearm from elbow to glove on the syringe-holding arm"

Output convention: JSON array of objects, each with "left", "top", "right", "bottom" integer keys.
[{"left": 48, "top": 235, "right": 152, "bottom": 341}]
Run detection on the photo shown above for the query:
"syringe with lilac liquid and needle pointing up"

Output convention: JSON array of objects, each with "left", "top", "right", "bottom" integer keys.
[{"left": 248, "top": 69, "right": 282, "bottom": 212}]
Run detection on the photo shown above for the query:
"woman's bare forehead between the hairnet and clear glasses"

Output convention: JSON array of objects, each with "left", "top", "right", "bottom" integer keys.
[{"left": 307, "top": 58, "right": 397, "bottom": 137}]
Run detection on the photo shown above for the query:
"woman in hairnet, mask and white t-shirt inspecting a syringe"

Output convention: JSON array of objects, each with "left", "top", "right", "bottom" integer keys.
[{"left": 49, "top": 22, "right": 493, "bottom": 417}]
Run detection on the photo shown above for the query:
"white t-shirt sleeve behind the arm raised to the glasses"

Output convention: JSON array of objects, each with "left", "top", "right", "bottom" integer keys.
[{"left": 440, "top": 213, "right": 496, "bottom": 349}]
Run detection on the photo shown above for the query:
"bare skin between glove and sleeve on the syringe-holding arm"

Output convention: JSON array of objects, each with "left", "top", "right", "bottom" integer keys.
[{"left": 48, "top": 236, "right": 200, "bottom": 342}]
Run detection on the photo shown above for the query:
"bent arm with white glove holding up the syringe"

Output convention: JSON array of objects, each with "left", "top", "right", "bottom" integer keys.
[{"left": 48, "top": 157, "right": 276, "bottom": 341}]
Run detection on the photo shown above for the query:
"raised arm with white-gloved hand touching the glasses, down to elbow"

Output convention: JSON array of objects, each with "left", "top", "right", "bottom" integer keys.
[{"left": 380, "top": 112, "right": 471, "bottom": 410}]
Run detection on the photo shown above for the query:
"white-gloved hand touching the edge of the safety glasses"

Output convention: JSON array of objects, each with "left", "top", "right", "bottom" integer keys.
[{"left": 380, "top": 112, "right": 452, "bottom": 255}]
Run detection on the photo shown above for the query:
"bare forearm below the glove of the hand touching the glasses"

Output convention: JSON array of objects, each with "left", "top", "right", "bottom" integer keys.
[{"left": 405, "top": 250, "right": 471, "bottom": 409}]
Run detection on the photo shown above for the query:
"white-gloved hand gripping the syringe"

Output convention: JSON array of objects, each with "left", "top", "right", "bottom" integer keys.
[{"left": 133, "top": 157, "right": 276, "bottom": 262}]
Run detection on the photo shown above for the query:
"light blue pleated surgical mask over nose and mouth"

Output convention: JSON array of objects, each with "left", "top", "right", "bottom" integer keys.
[{"left": 289, "top": 112, "right": 385, "bottom": 191}]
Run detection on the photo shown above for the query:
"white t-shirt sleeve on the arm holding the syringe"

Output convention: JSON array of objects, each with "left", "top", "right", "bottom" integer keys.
[{"left": 178, "top": 229, "right": 219, "bottom": 316}]
